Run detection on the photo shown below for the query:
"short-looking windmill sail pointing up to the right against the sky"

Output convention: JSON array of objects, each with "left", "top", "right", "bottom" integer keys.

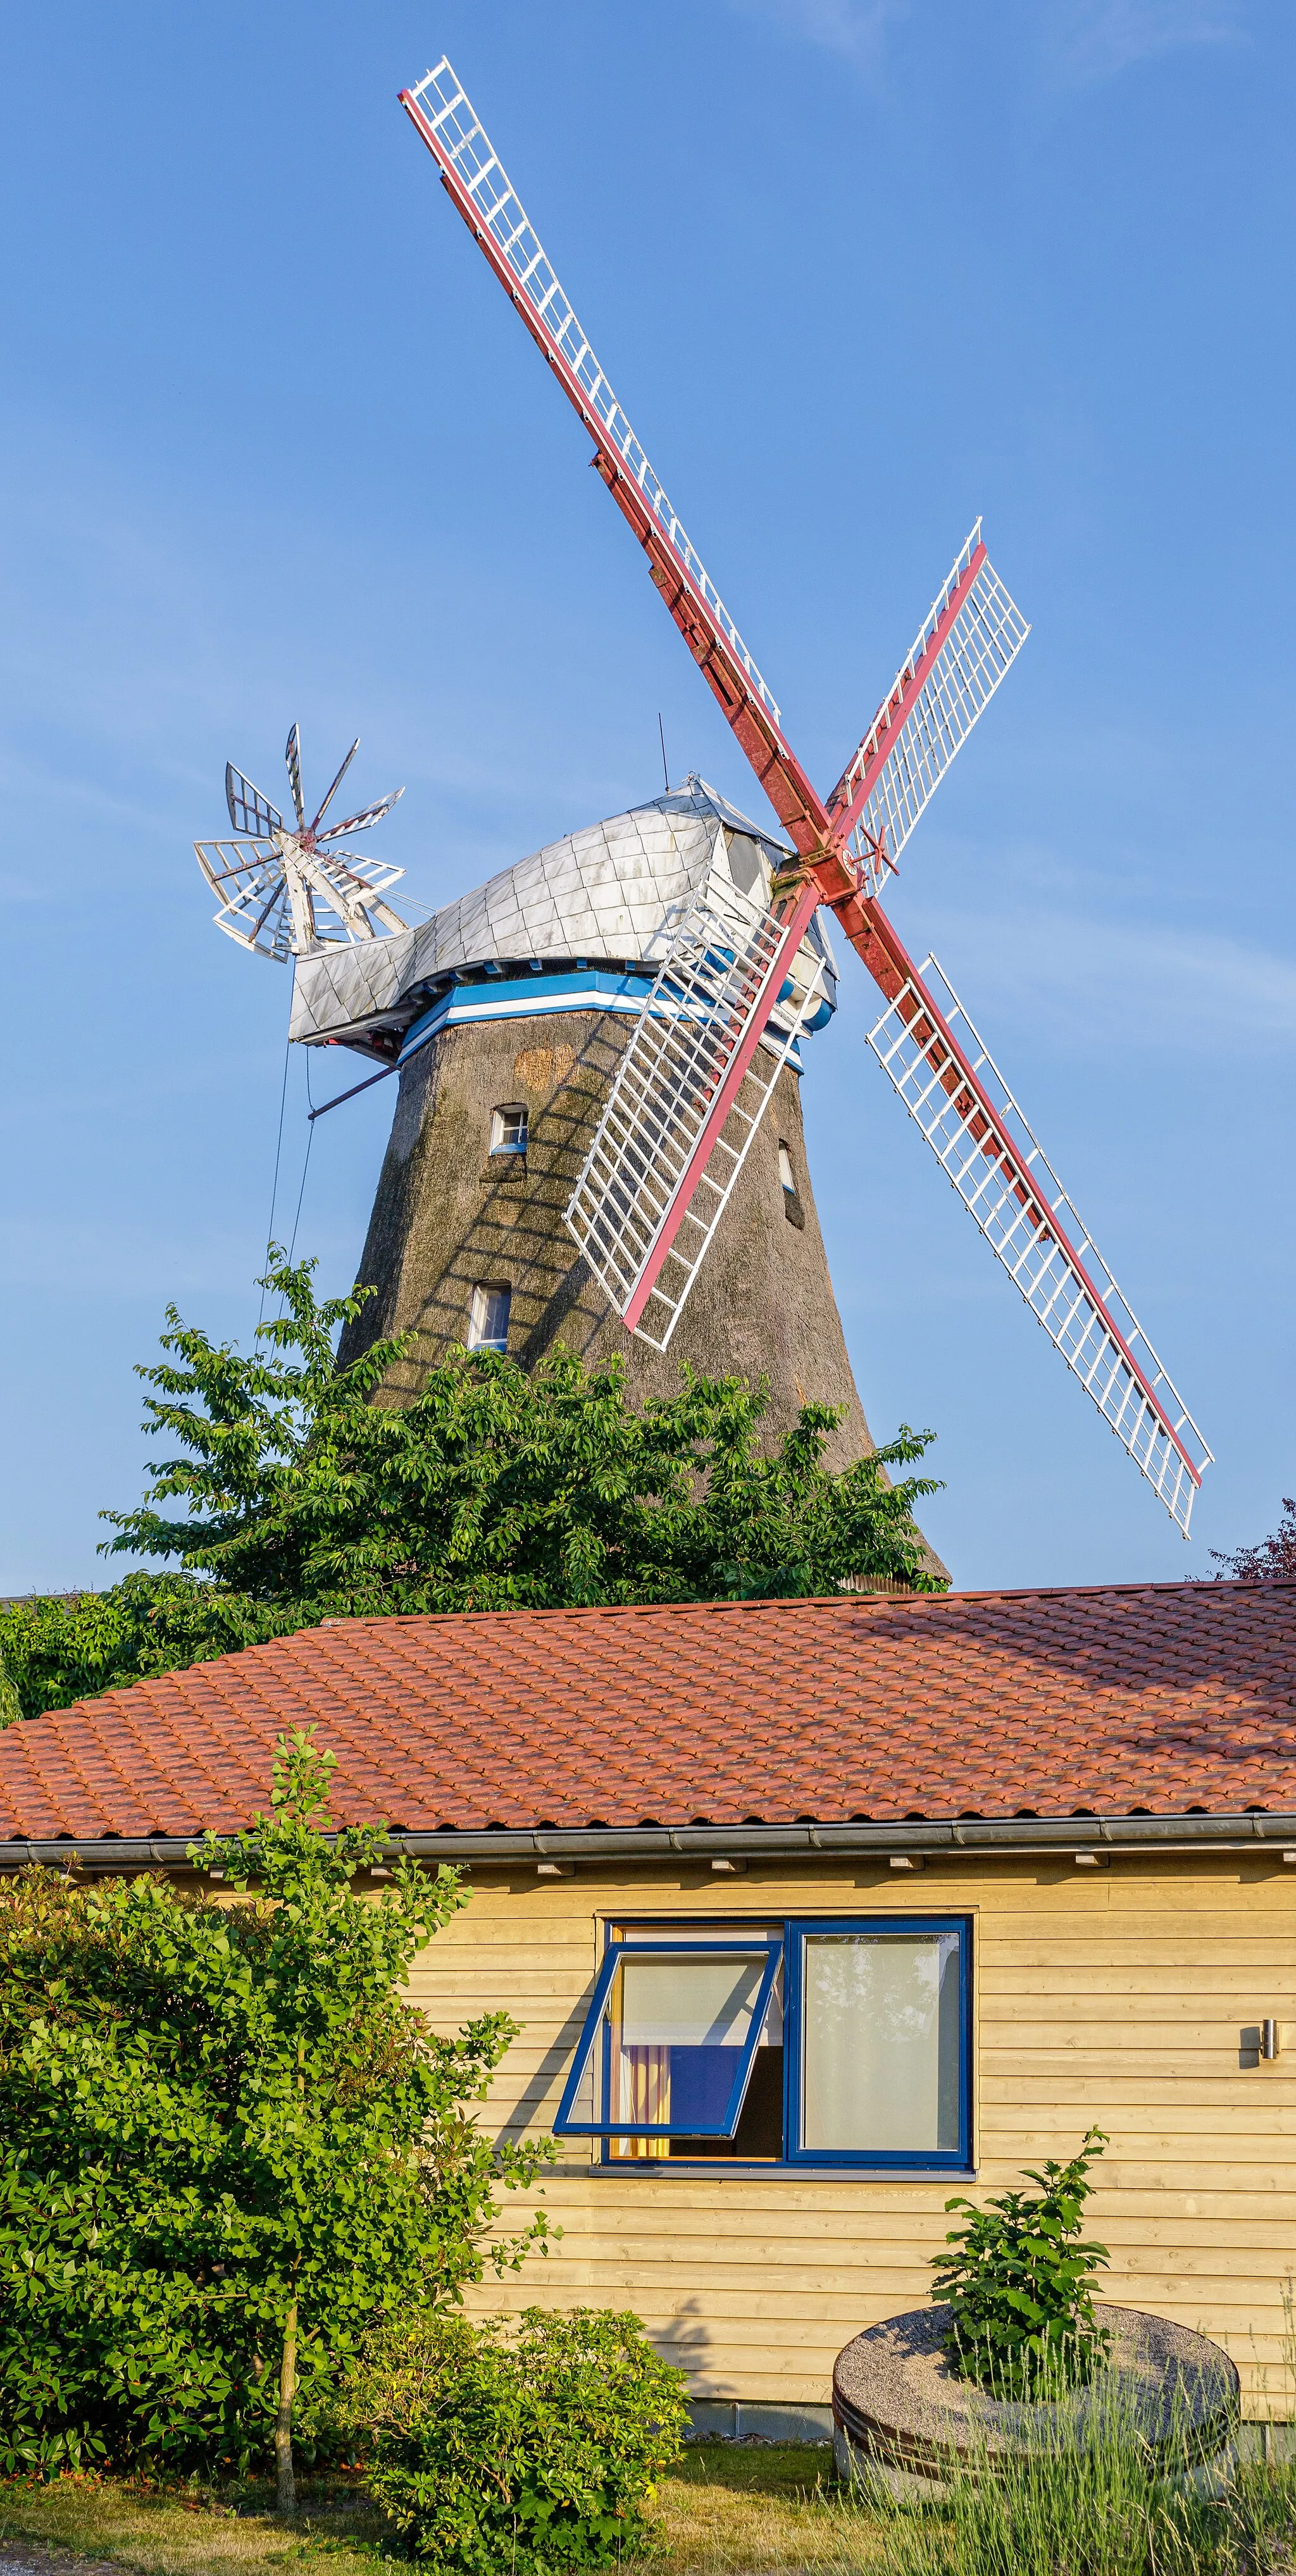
[{"left": 827, "top": 521, "right": 1031, "bottom": 894}]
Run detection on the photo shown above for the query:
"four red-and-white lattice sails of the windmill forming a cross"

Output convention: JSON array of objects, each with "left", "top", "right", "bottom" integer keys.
[{"left": 399, "top": 57, "right": 1211, "bottom": 1535}]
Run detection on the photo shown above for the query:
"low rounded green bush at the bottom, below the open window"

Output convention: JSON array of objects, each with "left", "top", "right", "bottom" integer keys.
[{"left": 332, "top": 2308, "right": 685, "bottom": 2576}]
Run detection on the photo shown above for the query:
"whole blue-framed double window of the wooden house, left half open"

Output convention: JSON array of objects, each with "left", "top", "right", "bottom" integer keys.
[{"left": 554, "top": 1917, "right": 971, "bottom": 2172}]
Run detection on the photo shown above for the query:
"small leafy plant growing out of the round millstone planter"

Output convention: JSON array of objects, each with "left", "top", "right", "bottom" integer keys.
[{"left": 933, "top": 2127, "right": 1108, "bottom": 2398}]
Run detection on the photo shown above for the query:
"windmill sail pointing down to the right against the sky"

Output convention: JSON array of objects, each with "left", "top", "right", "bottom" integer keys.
[{"left": 868, "top": 958, "right": 1211, "bottom": 1538}]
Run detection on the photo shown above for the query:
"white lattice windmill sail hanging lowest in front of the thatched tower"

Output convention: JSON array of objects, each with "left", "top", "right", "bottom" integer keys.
[{"left": 564, "top": 884, "right": 822, "bottom": 1350}]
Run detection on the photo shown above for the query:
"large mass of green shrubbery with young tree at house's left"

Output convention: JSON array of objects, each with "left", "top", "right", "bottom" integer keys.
[{"left": 0, "top": 1737, "right": 554, "bottom": 2470}]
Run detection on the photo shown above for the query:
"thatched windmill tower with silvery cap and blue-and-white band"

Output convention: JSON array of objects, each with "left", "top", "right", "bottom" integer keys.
[{"left": 291, "top": 778, "right": 871, "bottom": 1466}]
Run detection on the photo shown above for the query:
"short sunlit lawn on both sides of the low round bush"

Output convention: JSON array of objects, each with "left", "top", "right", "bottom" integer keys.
[{"left": 0, "top": 2442, "right": 876, "bottom": 2576}]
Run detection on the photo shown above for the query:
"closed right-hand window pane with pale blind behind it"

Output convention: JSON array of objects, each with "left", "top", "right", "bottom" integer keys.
[{"left": 801, "top": 1932, "right": 961, "bottom": 2156}]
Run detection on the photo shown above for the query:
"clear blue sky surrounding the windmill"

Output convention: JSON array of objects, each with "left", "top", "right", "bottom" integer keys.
[{"left": 0, "top": 0, "right": 1296, "bottom": 1592}]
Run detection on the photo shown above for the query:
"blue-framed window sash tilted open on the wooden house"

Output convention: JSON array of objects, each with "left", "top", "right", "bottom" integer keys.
[{"left": 554, "top": 1935, "right": 783, "bottom": 2138}]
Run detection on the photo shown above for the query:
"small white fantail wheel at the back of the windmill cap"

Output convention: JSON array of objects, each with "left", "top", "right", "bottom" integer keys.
[{"left": 193, "top": 724, "right": 404, "bottom": 963}]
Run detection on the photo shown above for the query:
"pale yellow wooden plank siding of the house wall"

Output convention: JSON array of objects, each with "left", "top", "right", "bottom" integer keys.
[{"left": 412, "top": 1855, "right": 1296, "bottom": 2417}]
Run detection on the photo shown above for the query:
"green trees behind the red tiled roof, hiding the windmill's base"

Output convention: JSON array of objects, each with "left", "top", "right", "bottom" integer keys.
[{"left": 0, "top": 1260, "right": 943, "bottom": 1713}]
